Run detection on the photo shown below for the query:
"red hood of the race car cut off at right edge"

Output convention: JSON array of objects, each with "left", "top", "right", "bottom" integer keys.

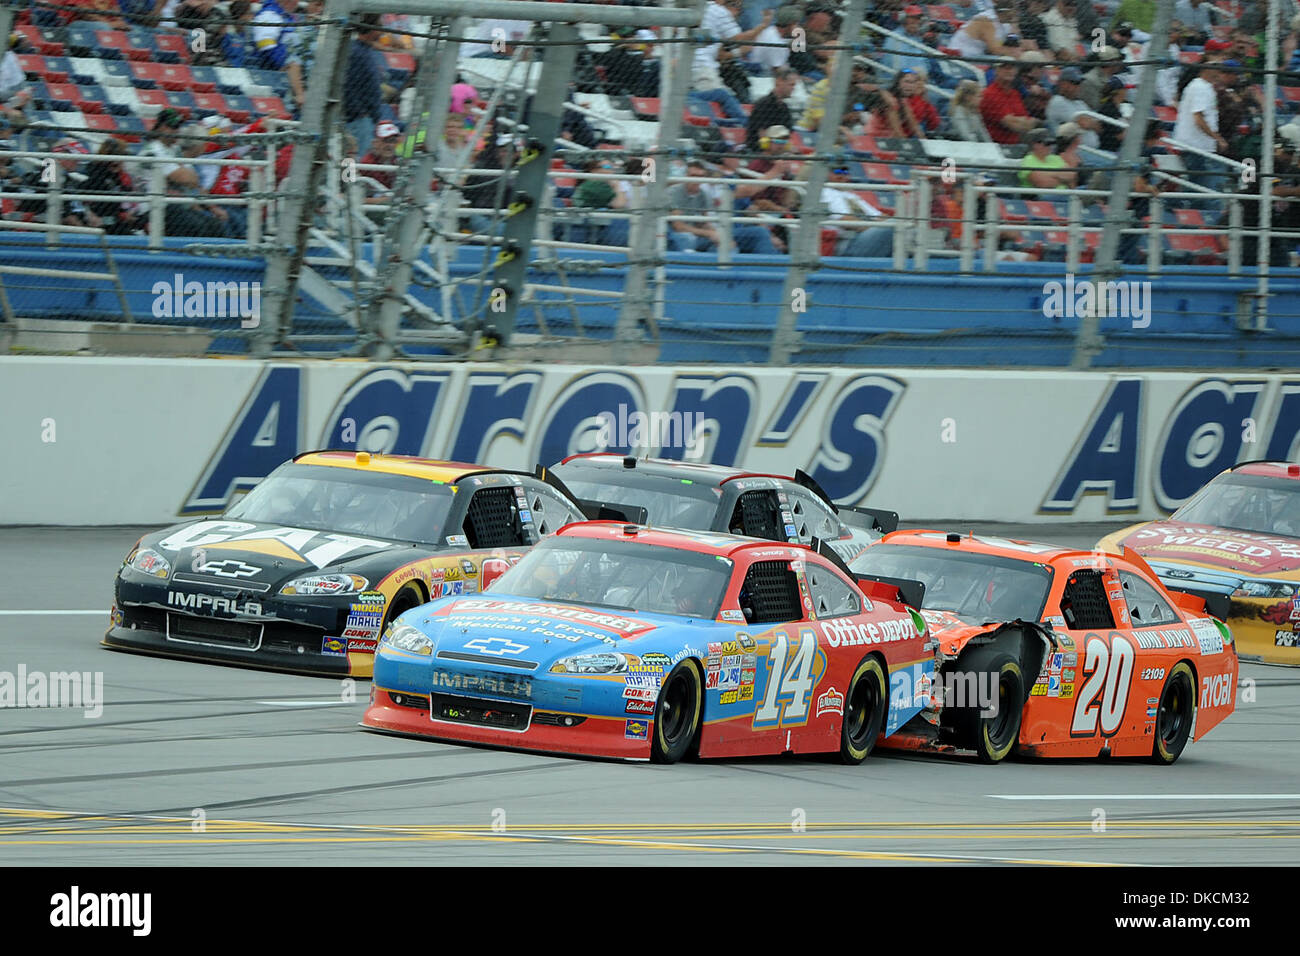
[{"left": 1121, "top": 520, "right": 1300, "bottom": 579}]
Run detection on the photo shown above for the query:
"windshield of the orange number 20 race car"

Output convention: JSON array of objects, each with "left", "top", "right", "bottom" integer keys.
[{"left": 852, "top": 544, "right": 1052, "bottom": 622}]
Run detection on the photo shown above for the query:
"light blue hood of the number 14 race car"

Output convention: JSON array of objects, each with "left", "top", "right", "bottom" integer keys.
[{"left": 402, "top": 594, "right": 712, "bottom": 671}]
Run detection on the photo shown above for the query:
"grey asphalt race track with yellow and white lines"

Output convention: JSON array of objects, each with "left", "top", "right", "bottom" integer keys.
[{"left": 0, "top": 524, "right": 1300, "bottom": 866}]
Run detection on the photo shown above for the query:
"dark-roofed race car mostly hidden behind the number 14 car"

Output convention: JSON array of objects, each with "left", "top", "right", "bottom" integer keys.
[{"left": 551, "top": 453, "right": 898, "bottom": 561}]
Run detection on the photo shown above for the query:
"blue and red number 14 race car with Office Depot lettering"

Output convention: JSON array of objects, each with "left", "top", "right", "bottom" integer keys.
[{"left": 361, "top": 522, "right": 935, "bottom": 763}]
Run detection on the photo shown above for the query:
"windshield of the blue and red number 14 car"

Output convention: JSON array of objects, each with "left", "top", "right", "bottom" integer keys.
[{"left": 489, "top": 536, "right": 732, "bottom": 619}]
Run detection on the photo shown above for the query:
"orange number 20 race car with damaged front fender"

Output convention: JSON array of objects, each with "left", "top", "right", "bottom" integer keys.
[{"left": 853, "top": 531, "right": 1238, "bottom": 763}]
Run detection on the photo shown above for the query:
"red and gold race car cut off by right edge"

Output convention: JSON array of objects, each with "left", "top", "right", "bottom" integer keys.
[{"left": 1097, "top": 462, "right": 1300, "bottom": 665}]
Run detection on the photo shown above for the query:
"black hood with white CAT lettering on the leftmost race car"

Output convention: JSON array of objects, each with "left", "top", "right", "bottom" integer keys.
[{"left": 139, "top": 519, "right": 410, "bottom": 593}]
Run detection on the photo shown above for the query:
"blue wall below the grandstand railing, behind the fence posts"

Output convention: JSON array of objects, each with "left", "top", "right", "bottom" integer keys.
[{"left": 0, "top": 239, "right": 1300, "bottom": 368}]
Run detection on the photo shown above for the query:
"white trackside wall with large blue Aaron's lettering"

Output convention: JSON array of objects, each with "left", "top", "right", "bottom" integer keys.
[{"left": 0, "top": 356, "right": 1300, "bottom": 527}]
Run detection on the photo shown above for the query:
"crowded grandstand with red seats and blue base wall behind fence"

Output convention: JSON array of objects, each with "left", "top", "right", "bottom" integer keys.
[{"left": 0, "top": 0, "right": 1300, "bottom": 365}]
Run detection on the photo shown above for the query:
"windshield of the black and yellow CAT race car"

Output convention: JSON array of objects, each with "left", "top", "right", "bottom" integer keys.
[{"left": 226, "top": 464, "right": 452, "bottom": 545}]
